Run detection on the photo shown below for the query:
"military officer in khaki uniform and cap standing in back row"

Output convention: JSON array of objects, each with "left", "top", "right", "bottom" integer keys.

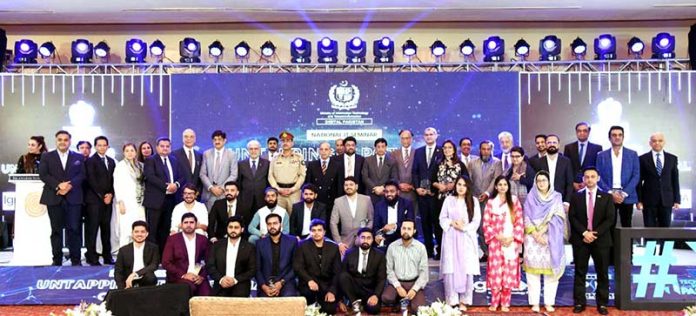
[{"left": 268, "top": 131, "right": 306, "bottom": 214}]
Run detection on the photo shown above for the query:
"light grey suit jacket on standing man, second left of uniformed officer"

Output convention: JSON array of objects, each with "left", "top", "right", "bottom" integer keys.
[{"left": 198, "top": 148, "right": 238, "bottom": 201}]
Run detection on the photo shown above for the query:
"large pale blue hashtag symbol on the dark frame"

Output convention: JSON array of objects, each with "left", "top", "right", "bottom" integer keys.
[{"left": 632, "top": 241, "right": 679, "bottom": 298}]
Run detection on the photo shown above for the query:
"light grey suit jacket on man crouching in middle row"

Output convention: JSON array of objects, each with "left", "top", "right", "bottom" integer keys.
[{"left": 330, "top": 194, "right": 374, "bottom": 246}]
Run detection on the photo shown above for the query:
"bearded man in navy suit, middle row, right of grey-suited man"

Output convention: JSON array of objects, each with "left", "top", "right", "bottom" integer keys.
[{"left": 373, "top": 181, "right": 416, "bottom": 249}]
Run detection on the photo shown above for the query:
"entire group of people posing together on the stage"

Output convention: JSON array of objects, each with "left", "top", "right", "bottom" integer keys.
[{"left": 19, "top": 122, "right": 680, "bottom": 314}]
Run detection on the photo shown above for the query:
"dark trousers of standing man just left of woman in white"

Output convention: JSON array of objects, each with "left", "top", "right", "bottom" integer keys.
[{"left": 85, "top": 203, "right": 114, "bottom": 263}]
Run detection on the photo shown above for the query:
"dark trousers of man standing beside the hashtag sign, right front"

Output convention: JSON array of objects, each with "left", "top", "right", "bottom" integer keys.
[{"left": 573, "top": 244, "right": 611, "bottom": 306}]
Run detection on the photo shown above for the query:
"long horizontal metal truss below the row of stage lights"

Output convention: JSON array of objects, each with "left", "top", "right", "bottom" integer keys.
[{"left": 6, "top": 59, "right": 690, "bottom": 75}]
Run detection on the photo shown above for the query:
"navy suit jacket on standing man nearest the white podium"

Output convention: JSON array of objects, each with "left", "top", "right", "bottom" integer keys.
[{"left": 39, "top": 150, "right": 85, "bottom": 206}]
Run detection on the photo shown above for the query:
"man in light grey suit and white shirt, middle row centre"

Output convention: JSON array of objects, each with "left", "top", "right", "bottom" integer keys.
[{"left": 330, "top": 177, "right": 374, "bottom": 256}]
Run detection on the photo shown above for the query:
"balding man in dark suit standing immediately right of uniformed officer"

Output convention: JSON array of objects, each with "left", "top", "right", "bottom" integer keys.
[{"left": 305, "top": 142, "right": 339, "bottom": 210}]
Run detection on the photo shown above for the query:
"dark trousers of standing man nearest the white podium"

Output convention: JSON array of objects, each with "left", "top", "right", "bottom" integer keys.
[{"left": 48, "top": 200, "right": 82, "bottom": 265}]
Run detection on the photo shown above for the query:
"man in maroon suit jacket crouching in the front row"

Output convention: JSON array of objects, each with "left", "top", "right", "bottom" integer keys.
[{"left": 162, "top": 213, "right": 210, "bottom": 296}]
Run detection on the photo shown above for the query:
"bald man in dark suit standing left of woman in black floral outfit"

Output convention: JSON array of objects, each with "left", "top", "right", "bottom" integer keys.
[{"left": 411, "top": 127, "right": 443, "bottom": 257}]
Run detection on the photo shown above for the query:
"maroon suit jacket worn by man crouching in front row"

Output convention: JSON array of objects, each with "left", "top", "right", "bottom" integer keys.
[{"left": 162, "top": 233, "right": 208, "bottom": 283}]
